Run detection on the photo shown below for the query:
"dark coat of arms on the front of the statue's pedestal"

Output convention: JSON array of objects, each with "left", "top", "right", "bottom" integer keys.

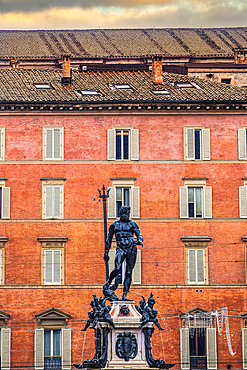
[{"left": 116, "top": 332, "right": 138, "bottom": 361}]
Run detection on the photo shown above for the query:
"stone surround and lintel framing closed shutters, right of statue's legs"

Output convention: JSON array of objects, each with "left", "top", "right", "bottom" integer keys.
[{"left": 180, "top": 236, "right": 211, "bottom": 286}]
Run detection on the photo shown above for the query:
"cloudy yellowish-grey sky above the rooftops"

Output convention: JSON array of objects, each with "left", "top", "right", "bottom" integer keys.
[{"left": 0, "top": 0, "right": 247, "bottom": 30}]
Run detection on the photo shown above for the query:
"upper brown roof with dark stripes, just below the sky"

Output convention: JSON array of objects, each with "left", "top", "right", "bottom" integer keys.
[{"left": 0, "top": 27, "right": 247, "bottom": 58}]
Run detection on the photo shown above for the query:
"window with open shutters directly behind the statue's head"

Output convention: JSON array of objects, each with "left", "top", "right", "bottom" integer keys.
[{"left": 108, "top": 186, "right": 140, "bottom": 218}]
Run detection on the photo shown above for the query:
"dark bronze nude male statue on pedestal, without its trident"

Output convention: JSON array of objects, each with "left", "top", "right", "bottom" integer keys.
[{"left": 103, "top": 207, "right": 143, "bottom": 301}]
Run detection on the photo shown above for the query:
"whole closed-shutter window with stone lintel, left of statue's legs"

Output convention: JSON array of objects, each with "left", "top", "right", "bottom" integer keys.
[{"left": 38, "top": 237, "right": 68, "bottom": 285}]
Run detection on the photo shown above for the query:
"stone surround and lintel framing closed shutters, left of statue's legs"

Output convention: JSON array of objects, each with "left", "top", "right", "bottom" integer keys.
[{"left": 37, "top": 236, "right": 68, "bottom": 285}]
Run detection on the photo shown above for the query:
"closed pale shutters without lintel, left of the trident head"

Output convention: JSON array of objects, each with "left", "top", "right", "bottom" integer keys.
[{"left": 44, "top": 185, "right": 63, "bottom": 218}]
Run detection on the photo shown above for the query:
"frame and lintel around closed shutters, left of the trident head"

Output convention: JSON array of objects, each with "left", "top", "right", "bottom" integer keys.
[{"left": 40, "top": 177, "right": 66, "bottom": 220}]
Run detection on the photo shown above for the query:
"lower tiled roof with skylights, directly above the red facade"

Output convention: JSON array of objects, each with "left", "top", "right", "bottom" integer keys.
[{"left": 0, "top": 69, "right": 247, "bottom": 104}]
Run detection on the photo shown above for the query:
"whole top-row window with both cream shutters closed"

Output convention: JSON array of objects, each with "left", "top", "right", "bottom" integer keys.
[{"left": 43, "top": 127, "right": 63, "bottom": 160}]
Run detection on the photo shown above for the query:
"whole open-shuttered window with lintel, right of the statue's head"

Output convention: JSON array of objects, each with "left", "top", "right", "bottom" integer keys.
[{"left": 179, "top": 177, "right": 212, "bottom": 218}]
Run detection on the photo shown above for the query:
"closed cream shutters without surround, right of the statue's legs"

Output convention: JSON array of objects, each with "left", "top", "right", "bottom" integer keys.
[{"left": 187, "top": 249, "right": 205, "bottom": 284}]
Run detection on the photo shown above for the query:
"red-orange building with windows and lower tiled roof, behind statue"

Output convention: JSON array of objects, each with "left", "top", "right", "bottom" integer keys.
[{"left": 0, "top": 63, "right": 247, "bottom": 369}]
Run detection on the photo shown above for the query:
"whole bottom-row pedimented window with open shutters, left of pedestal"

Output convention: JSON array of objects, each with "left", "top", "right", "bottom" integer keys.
[{"left": 34, "top": 308, "right": 71, "bottom": 370}]
